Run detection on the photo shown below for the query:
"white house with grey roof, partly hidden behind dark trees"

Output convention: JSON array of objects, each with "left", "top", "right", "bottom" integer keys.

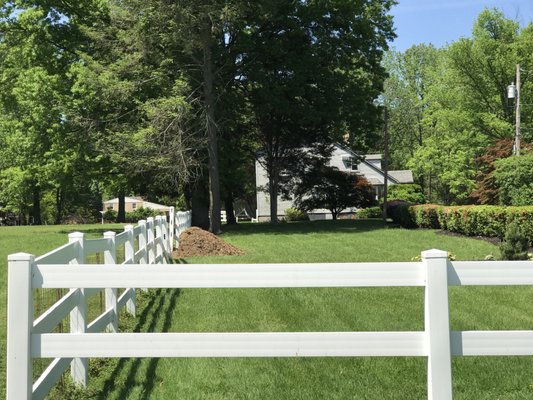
[{"left": 255, "top": 143, "right": 413, "bottom": 222}]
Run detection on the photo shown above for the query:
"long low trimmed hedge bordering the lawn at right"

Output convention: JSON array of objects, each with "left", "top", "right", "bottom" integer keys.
[{"left": 391, "top": 203, "right": 533, "bottom": 242}]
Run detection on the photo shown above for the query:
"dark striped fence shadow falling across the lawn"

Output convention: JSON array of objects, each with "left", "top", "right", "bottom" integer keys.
[{"left": 98, "top": 289, "right": 180, "bottom": 400}]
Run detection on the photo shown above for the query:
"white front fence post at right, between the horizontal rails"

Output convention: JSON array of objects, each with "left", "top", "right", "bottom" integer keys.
[{"left": 422, "top": 249, "right": 452, "bottom": 400}]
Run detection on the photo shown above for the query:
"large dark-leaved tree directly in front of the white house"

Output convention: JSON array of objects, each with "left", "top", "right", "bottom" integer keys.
[{"left": 241, "top": 0, "right": 393, "bottom": 223}]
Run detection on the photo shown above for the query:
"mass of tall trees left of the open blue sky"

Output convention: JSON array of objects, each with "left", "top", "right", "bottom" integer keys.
[{"left": 0, "top": 0, "right": 394, "bottom": 228}]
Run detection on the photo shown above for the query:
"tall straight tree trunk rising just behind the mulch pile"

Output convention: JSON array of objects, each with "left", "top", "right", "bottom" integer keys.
[{"left": 202, "top": 21, "right": 222, "bottom": 234}]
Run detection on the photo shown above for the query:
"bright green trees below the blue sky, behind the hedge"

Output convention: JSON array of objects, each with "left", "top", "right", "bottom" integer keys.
[{"left": 384, "top": 10, "right": 533, "bottom": 205}]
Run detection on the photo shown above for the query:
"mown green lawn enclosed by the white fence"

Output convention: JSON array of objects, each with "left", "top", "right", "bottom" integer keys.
[{"left": 0, "top": 220, "right": 533, "bottom": 400}]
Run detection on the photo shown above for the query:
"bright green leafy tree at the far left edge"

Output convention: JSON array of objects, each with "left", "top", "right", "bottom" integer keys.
[{"left": 0, "top": 1, "right": 105, "bottom": 224}]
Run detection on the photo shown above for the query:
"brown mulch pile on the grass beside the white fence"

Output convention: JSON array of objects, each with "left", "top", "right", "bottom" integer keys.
[{"left": 172, "top": 227, "right": 244, "bottom": 258}]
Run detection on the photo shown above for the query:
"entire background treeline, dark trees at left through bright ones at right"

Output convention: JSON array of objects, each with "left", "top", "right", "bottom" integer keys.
[{"left": 0, "top": 0, "right": 533, "bottom": 228}]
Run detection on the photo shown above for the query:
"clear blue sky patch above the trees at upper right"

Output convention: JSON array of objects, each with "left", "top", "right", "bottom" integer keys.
[{"left": 392, "top": 0, "right": 533, "bottom": 51}]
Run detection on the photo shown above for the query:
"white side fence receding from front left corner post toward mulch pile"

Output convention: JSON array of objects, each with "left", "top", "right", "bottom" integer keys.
[{"left": 7, "top": 209, "right": 190, "bottom": 399}]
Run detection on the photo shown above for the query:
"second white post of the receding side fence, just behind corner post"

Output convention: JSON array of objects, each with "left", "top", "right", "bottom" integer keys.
[{"left": 68, "top": 232, "right": 89, "bottom": 387}]
